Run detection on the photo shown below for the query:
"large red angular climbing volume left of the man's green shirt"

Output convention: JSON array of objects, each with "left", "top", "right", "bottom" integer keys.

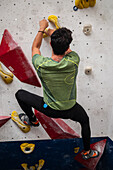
[{"left": 0, "top": 30, "right": 41, "bottom": 87}]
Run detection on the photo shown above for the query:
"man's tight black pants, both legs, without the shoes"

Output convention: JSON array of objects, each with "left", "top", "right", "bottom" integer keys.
[{"left": 15, "top": 90, "right": 90, "bottom": 151}]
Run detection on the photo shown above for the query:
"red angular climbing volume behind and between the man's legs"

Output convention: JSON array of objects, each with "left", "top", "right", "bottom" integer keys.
[{"left": 35, "top": 110, "right": 80, "bottom": 139}]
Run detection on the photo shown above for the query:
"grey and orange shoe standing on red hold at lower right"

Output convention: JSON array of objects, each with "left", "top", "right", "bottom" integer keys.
[{"left": 82, "top": 150, "right": 99, "bottom": 159}]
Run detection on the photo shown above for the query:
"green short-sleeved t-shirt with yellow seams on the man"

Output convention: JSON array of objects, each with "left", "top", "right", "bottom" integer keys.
[{"left": 32, "top": 51, "right": 80, "bottom": 110}]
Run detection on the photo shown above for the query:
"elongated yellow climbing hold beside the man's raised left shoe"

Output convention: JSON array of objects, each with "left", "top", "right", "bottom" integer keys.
[{"left": 11, "top": 111, "right": 30, "bottom": 133}]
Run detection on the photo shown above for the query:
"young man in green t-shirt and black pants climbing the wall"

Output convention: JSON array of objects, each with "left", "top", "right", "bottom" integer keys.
[{"left": 16, "top": 19, "right": 99, "bottom": 159}]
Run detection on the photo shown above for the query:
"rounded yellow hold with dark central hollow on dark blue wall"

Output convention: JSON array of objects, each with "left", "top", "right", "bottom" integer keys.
[{"left": 20, "top": 143, "right": 35, "bottom": 154}]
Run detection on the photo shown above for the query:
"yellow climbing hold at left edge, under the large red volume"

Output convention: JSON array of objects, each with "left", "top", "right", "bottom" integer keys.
[{"left": 0, "top": 64, "right": 13, "bottom": 84}]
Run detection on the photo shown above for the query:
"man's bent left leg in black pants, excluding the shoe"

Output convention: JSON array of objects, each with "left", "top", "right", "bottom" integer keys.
[{"left": 15, "top": 89, "right": 65, "bottom": 122}]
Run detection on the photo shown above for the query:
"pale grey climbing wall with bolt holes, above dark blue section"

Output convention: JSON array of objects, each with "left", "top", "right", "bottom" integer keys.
[{"left": 0, "top": 0, "right": 113, "bottom": 141}]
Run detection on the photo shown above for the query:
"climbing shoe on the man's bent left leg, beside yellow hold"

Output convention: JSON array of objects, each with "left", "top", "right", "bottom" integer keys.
[{"left": 19, "top": 113, "right": 40, "bottom": 126}]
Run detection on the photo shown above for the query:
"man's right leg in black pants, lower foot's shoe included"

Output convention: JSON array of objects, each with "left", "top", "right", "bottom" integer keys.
[{"left": 70, "top": 103, "right": 99, "bottom": 159}]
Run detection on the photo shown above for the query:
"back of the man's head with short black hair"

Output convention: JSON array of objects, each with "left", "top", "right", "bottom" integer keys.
[{"left": 51, "top": 27, "right": 72, "bottom": 55}]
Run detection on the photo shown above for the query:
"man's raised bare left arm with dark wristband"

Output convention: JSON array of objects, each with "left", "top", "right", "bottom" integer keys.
[{"left": 32, "top": 19, "right": 48, "bottom": 57}]
